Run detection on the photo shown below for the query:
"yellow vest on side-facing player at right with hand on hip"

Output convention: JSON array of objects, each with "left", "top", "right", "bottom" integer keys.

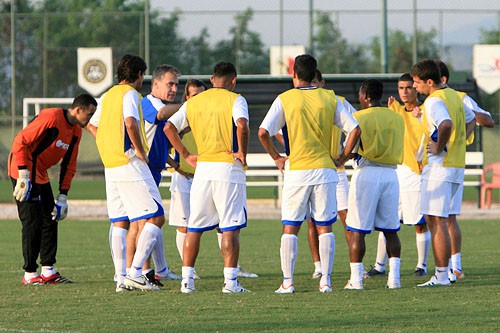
[{"left": 423, "top": 88, "right": 466, "bottom": 168}]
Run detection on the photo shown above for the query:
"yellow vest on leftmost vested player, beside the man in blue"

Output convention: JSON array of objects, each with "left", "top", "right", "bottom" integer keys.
[{"left": 96, "top": 84, "right": 149, "bottom": 168}]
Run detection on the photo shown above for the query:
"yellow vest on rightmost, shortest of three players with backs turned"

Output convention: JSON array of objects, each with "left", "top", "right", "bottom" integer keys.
[{"left": 353, "top": 106, "right": 405, "bottom": 164}]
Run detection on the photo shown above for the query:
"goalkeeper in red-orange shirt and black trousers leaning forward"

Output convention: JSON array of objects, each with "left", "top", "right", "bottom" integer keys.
[{"left": 8, "top": 94, "right": 97, "bottom": 285}]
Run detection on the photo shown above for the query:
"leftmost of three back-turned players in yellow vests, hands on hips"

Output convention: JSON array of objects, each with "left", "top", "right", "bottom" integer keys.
[{"left": 165, "top": 62, "right": 249, "bottom": 293}]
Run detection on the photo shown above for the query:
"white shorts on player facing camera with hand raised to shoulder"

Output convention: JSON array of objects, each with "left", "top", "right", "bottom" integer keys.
[{"left": 396, "top": 165, "right": 425, "bottom": 225}]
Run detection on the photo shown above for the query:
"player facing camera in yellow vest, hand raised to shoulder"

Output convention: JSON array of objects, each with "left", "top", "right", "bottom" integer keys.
[{"left": 367, "top": 73, "right": 431, "bottom": 277}]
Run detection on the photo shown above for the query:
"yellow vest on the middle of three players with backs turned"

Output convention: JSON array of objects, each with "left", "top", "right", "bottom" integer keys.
[{"left": 279, "top": 88, "right": 338, "bottom": 170}]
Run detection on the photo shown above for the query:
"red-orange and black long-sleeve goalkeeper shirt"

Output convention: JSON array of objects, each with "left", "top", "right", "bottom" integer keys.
[{"left": 8, "top": 108, "right": 82, "bottom": 191}]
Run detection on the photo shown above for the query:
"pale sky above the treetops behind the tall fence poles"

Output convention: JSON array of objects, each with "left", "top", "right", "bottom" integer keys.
[{"left": 150, "top": 0, "right": 500, "bottom": 46}]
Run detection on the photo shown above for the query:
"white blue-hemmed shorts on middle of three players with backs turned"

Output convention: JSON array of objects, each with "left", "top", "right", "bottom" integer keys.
[{"left": 281, "top": 182, "right": 337, "bottom": 226}]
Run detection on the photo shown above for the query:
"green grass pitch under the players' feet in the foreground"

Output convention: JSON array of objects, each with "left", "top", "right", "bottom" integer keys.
[{"left": 0, "top": 220, "right": 500, "bottom": 332}]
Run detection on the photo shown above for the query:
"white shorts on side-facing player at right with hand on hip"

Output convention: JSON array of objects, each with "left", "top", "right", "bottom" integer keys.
[{"left": 420, "top": 179, "right": 463, "bottom": 217}]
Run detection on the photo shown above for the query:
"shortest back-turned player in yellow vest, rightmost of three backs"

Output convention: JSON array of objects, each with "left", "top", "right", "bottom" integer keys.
[{"left": 344, "top": 80, "right": 404, "bottom": 289}]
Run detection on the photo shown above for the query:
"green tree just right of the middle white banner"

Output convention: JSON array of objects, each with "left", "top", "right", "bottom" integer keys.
[{"left": 313, "top": 11, "right": 368, "bottom": 73}]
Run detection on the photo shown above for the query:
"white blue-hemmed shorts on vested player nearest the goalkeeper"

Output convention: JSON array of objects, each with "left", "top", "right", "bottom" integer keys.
[{"left": 106, "top": 174, "right": 165, "bottom": 222}]
